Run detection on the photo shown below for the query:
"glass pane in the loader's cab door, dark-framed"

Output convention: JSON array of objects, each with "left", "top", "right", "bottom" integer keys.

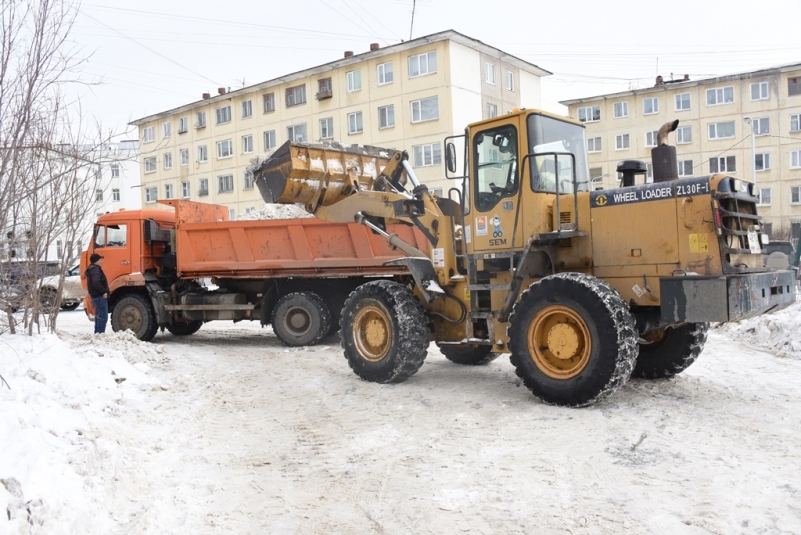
[{"left": 473, "top": 125, "right": 519, "bottom": 212}]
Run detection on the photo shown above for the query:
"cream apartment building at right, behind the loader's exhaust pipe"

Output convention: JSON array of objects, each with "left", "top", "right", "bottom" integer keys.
[{"left": 562, "top": 64, "right": 801, "bottom": 233}]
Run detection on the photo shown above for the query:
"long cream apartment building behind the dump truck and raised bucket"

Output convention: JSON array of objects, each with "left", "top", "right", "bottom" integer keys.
[{"left": 131, "top": 30, "right": 551, "bottom": 218}]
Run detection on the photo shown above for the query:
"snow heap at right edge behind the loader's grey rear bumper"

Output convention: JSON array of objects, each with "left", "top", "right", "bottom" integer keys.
[{"left": 715, "top": 301, "right": 801, "bottom": 360}]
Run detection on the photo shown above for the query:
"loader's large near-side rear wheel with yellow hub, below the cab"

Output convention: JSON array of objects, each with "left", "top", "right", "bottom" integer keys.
[{"left": 508, "top": 273, "right": 637, "bottom": 407}]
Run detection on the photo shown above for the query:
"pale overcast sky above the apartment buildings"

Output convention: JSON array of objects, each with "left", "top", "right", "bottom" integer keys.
[{"left": 70, "top": 0, "right": 801, "bottom": 138}]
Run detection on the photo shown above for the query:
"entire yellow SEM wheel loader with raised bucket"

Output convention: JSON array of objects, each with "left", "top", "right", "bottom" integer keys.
[{"left": 250, "top": 110, "right": 795, "bottom": 407}]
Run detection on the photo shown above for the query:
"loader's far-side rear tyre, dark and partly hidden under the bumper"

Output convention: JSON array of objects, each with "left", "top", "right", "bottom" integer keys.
[{"left": 631, "top": 323, "right": 709, "bottom": 379}]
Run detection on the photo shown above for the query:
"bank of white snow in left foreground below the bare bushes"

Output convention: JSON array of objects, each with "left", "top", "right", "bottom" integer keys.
[{"left": 0, "top": 333, "right": 162, "bottom": 534}]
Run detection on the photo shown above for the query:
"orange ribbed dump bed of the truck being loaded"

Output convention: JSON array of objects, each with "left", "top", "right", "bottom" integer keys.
[{"left": 162, "top": 201, "right": 425, "bottom": 278}]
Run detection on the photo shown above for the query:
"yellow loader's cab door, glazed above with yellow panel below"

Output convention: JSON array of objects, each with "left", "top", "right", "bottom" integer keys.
[{"left": 465, "top": 120, "right": 523, "bottom": 253}]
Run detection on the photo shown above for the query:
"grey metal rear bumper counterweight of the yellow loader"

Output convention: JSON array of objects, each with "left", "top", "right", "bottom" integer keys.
[{"left": 660, "top": 271, "right": 795, "bottom": 324}]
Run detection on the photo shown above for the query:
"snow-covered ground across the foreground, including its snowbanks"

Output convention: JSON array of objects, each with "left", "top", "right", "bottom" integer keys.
[{"left": 0, "top": 305, "right": 801, "bottom": 534}]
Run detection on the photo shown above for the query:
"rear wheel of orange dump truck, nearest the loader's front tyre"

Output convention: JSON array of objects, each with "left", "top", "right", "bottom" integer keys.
[{"left": 270, "top": 292, "right": 331, "bottom": 346}]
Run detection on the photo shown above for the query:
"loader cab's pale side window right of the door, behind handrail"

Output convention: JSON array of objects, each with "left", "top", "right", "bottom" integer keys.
[{"left": 527, "top": 114, "right": 590, "bottom": 193}]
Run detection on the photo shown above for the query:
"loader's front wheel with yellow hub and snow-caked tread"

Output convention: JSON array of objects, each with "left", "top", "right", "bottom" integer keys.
[{"left": 341, "top": 280, "right": 428, "bottom": 383}]
